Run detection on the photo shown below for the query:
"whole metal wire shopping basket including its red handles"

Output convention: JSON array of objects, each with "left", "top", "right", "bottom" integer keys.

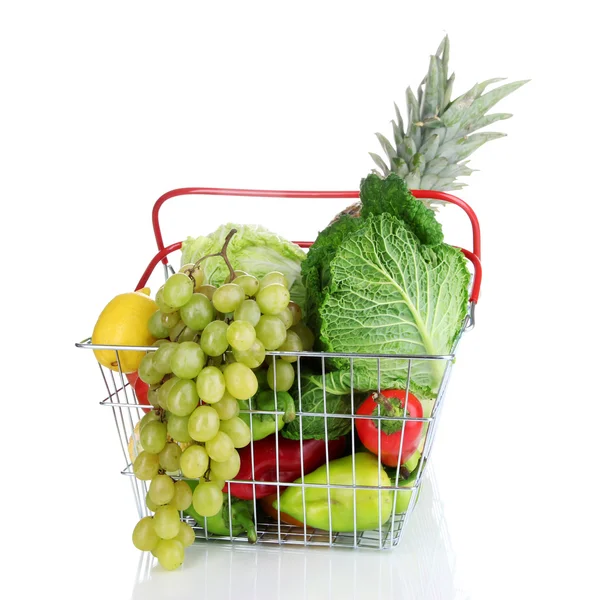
[{"left": 76, "top": 188, "right": 481, "bottom": 549}]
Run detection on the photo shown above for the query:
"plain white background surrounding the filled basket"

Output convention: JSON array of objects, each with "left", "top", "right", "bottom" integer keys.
[{"left": 0, "top": 0, "right": 597, "bottom": 600}]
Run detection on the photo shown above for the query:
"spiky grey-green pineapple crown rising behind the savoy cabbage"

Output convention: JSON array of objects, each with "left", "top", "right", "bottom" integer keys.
[{"left": 334, "top": 36, "right": 528, "bottom": 220}]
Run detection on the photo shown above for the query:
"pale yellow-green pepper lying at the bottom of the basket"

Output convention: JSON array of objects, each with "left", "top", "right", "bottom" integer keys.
[{"left": 273, "top": 452, "right": 393, "bottom": 532}]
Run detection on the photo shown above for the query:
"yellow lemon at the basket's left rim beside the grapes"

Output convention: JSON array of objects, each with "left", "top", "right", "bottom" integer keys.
[{"left": 91, "top": 288, "right": 158, "bottom": 373}]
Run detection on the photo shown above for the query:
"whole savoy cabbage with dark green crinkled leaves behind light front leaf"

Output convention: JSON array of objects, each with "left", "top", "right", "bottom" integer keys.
[{"left": 303, "top": 174, "right": 470, "bottom": 397}]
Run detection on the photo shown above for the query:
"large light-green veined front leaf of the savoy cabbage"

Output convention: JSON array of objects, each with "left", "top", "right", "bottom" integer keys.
[{"left": 319, "top": 214, "right": 470, "bottom": 392}]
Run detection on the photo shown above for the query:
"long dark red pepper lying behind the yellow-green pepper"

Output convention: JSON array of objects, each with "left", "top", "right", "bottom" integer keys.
[{"left": 223, "top": 435, "right": 346, "bottom": 500}]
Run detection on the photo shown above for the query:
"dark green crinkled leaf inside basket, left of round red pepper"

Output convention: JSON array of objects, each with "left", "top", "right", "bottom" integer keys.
[{"left": 281, "top": 373, "right": 358, "bottom": 440}]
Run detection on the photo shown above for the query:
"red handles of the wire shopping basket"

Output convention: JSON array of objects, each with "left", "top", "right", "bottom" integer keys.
[{"left": 142, "top": 187, "right": 482, "bottom": 303}]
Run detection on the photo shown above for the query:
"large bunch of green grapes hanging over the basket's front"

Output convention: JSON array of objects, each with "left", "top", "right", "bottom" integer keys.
[{"left": 133, "top": 264, "right": 313, "bottom": 569}]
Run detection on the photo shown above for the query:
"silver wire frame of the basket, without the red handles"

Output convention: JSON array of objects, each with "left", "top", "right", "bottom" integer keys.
[{"left": 76, "top": 322, "right": 470, "bottom": 549}]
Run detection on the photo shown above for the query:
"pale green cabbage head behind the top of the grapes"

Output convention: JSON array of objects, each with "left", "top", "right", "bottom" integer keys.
[{"left": 181, "top": 223, "right": 306, "bottom": 307}]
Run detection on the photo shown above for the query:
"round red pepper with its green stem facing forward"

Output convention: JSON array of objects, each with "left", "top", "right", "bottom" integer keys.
[{"left": 355, "top": 390, "right": 423, "bottom": 467}]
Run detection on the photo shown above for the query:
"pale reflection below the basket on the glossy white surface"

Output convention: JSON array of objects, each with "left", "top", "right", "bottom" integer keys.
[{"left": 132, "top": 464, "right": 469, "bottom": 600}]
